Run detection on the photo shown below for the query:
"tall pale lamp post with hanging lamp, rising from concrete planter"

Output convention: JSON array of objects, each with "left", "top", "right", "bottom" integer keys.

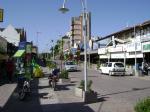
[{"left": 59, "top": 0, "right": 87, "bottom": 92}]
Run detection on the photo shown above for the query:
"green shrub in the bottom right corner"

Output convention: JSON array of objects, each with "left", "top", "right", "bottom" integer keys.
[{"left": 134, "top": 97, "right": 150, "bottom": 112}]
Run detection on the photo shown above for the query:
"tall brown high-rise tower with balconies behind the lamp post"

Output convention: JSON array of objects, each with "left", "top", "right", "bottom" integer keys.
[{"left": 71, "top": 12, "right": 91, "bottom": 47}]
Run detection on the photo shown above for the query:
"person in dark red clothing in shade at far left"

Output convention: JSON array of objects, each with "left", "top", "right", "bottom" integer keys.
[{"left": 6, "top": 58, "right": 14, "bottom": 82}]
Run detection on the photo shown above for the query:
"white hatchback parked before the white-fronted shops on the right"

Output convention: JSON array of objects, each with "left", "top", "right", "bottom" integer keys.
[{"left": 99, "top": 62, "right": 125, "bottom": 75}]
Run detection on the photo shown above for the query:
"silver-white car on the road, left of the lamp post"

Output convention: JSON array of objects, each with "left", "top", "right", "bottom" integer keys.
[{"left": 64, "top": 61, "right": 77, "bottom": 71}]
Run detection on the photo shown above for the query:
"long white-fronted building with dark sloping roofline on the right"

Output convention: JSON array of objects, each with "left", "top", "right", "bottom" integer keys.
[{"left": 98, "top": 21, "right": 150, "bottom": 71}]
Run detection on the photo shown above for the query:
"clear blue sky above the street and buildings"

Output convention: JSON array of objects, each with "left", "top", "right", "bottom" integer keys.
[{"left": 0, "top": 0, "right": 150, "bottom": 51}]
